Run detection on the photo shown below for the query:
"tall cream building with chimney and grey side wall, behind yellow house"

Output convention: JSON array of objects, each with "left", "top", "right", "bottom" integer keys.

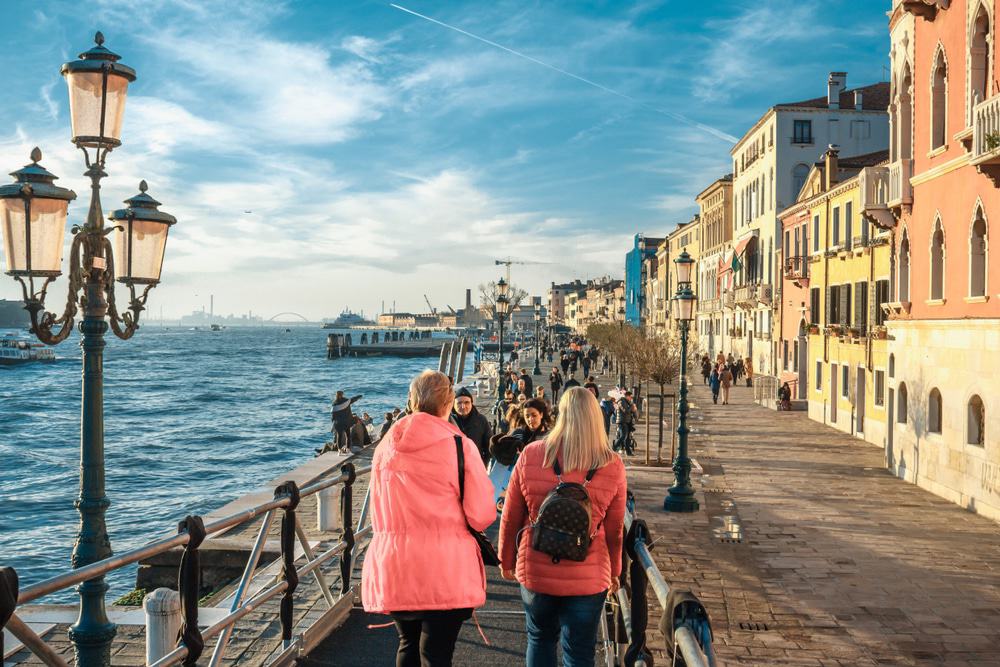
[{"left": 727, "top": 72, "right": 889, "bottom": 375}]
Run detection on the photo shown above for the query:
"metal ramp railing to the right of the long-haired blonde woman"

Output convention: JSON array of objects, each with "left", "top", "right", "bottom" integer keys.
[{"left": 605, "top": 493, "right": 716, "bottom": 667}]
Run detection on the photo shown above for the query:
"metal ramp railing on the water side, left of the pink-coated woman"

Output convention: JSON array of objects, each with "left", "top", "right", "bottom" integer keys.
[{"left": 0, "top": 462, "right": 372, "bottom": 667}]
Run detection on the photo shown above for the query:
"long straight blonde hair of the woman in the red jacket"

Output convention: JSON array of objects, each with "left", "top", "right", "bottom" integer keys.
[{"left": 542, "top": 387, "right": 615, "bottom": 472}]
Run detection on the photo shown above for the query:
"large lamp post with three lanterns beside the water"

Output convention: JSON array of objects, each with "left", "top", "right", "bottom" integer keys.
[{"left": 0, "top": 33, "right": 176, "bottom": 667}]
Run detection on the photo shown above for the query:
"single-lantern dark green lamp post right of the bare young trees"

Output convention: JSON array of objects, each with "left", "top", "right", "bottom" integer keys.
[{"left": 663, "top": 251, "right": 698, "bottom": 512}]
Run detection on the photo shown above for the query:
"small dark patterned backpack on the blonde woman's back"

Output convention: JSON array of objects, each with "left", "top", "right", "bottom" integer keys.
[{"left": 531, "top": 459, "right": 600, "bottom": 563}]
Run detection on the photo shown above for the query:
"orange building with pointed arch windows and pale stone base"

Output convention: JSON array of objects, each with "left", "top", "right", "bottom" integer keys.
[{"left": 886, "top": 0, "right": 1000, "bottom": 519}]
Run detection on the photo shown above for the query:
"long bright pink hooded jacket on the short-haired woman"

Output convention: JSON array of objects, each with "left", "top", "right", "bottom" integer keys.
[{"left": 361, "top": 412, "right": 496, "bottom": 613}]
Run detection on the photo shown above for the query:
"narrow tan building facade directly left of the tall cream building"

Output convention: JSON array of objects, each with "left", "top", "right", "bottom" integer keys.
[{"left": 695, "top": 174, "right": 733, "bottom": 359}]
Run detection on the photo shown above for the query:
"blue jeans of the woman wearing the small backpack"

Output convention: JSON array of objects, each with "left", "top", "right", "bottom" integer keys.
[{"left": 521, "top": 586, "right": 607, "bottom": 667}]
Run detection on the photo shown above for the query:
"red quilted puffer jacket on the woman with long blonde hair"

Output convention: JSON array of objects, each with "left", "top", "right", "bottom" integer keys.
[{"left": 500, "top": 441, "right": 626, "bottom": 595}]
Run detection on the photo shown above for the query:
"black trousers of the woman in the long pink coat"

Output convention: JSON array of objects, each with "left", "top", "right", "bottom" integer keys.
[{"left": 391, "top": 609, "right": 472, "bottom": 667}]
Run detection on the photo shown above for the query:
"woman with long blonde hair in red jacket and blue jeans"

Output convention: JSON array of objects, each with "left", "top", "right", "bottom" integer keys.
[{"left": 500, "top": 388, "right": 627, "bottom": 667}]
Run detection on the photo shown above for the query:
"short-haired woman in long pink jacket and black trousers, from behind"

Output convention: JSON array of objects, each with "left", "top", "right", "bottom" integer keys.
[{"left": 361, "top": 371, "right": 496, "bottom": 667}]
